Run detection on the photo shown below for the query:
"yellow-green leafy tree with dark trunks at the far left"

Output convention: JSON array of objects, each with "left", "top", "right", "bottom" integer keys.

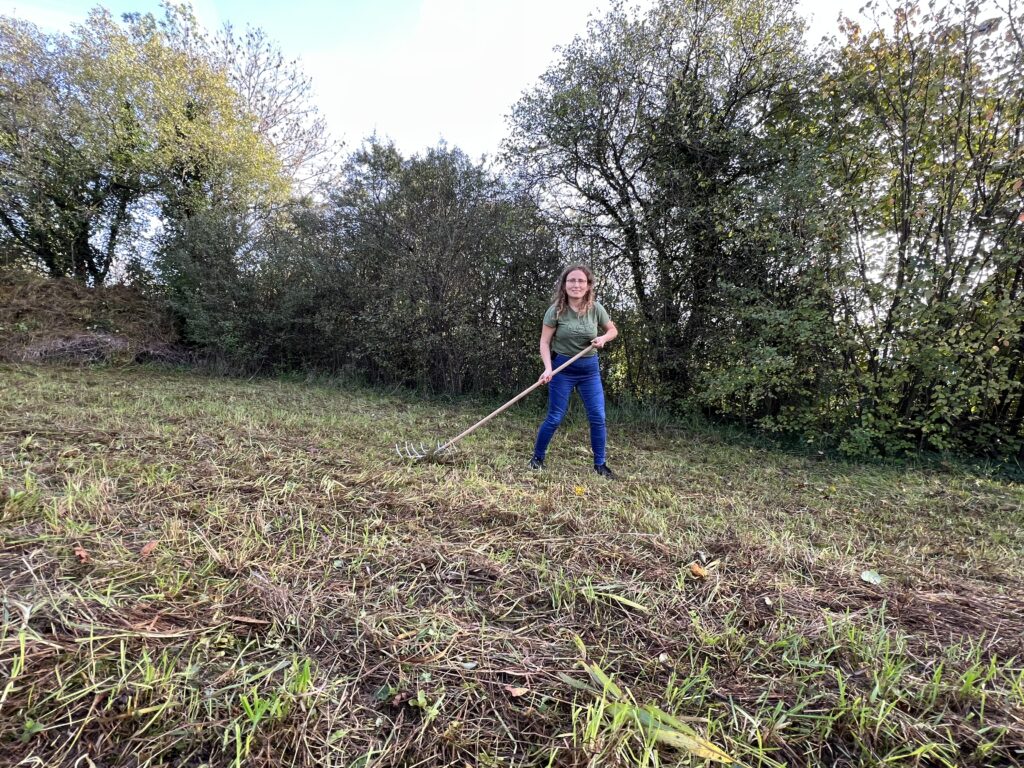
[{"left": 0, "top": 6, "right": 287, "bottom": 285}]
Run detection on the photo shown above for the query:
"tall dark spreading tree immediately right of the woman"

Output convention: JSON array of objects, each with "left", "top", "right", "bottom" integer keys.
[{"left": 507, "top": 0, "right": 827, "bottom": 399}]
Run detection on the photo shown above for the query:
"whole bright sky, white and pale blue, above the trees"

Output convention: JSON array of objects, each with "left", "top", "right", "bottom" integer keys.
[{"left": 0, "top": 0, "right": 863, "bottom": 159}]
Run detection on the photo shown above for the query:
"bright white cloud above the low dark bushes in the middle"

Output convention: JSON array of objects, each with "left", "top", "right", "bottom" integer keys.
[{"left": 302, "top": 0, "right": 606, "bottom": 157}]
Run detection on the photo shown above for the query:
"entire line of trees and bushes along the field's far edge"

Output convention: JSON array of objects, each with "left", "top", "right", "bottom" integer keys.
[{"left": 0, "top": 0, "right": 1024, "bottom": 456}]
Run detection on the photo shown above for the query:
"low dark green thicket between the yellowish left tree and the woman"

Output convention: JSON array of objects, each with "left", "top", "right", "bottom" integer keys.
[{"left": 159, "top": 141, "right": 558, "bottom": 393}]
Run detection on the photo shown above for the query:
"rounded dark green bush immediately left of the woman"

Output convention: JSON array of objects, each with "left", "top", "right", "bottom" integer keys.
[{"left": 330, "top": 140, "right": 558, "bottom": 392}]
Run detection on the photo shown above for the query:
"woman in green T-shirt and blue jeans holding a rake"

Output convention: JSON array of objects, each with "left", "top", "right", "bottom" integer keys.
[{"left": 529, "top": 264, "right": 618, "bottom": 478}]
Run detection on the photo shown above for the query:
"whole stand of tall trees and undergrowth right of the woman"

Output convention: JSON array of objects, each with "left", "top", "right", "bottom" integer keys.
[{"left": 508, "top": 0, "right": 1024, "bottom": 456}]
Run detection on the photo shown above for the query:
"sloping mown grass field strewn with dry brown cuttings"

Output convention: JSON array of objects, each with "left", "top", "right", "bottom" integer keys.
[{"left": 0, "top": 366, "right": 1024, "bottom": 767}]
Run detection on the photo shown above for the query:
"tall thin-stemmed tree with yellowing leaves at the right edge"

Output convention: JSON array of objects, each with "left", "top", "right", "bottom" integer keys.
[{"left": 828, "top": 2, "right": 1024, "bottom": 453}]
